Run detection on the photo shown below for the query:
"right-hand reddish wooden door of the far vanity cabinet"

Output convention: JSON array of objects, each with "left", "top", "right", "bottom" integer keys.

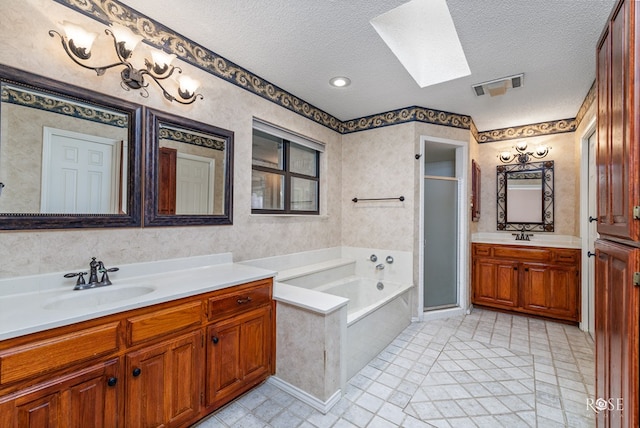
[{"left": 519, "top": 263, "right": 580, "bottom": 322}]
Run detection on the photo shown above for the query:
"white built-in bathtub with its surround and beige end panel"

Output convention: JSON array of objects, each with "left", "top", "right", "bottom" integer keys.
[{"left": 241, "top": 247, "right": 415, "bottom": 413}]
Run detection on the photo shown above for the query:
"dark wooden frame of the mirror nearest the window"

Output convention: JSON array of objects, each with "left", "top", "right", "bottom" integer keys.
[{"left": 144, "top": 108, "right": 234, "bottom": 227}]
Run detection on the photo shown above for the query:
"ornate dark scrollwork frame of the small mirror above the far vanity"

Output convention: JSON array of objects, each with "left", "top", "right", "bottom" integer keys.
[{"left": 496, "top": 161, "right": 554, "bottom": 232}]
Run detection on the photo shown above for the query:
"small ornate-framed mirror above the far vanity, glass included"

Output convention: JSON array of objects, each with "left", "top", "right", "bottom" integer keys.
[{"left": 496, "top": 161, "right": 554, "bottom": 232}]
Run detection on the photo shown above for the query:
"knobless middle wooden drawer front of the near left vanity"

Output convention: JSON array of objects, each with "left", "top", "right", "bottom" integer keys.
[{"left": 127, "top": 300, "right": 202, "bottom": 345}]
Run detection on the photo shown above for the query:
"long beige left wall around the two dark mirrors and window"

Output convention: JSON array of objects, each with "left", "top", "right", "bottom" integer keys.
[{"left": 0, "top": 0, "right": 342, "bottom": 277}]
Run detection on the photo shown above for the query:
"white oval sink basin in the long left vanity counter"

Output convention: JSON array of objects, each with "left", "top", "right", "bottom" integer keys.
[{"left": 43, "top": 285, "right": 155, "bottom": 309}]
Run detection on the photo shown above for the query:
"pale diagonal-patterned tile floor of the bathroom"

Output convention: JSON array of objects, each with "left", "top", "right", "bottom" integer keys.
[{"left": 197, "top": 309, "right": 595, "bottom": 428}]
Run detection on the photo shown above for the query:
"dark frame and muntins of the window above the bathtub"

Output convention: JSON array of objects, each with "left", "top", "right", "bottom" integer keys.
[{"left": 251, "top": 133, "right": 322, "bottom": 215}]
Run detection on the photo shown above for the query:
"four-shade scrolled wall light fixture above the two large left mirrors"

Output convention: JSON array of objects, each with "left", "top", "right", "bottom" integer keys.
[{"left": 49, "top": 21, "right": 203, "bottom": 104}]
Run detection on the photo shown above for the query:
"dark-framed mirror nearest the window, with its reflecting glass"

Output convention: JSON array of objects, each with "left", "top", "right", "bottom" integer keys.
[{"left": 144, "top": 109, "right": 233, "bottom": 226}]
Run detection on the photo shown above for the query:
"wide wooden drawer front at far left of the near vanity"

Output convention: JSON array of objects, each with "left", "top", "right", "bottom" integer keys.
[{"left": 0, "top": 322, "right": 119, "bottom": 385}]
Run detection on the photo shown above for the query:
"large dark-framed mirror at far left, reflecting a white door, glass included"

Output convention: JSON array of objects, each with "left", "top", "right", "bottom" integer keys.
[{"left": 0, "top": 65, "right": 142, "bottom": 229}]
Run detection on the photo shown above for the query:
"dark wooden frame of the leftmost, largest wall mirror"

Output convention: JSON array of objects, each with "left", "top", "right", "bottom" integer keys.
[{"left": 0, "top": 64, "right": 142, "bottom": 230}]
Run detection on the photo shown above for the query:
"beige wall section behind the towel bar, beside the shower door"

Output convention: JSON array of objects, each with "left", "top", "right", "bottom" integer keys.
[{"left": 342, "top": 123, "right": 419, "bottom": 251}]
